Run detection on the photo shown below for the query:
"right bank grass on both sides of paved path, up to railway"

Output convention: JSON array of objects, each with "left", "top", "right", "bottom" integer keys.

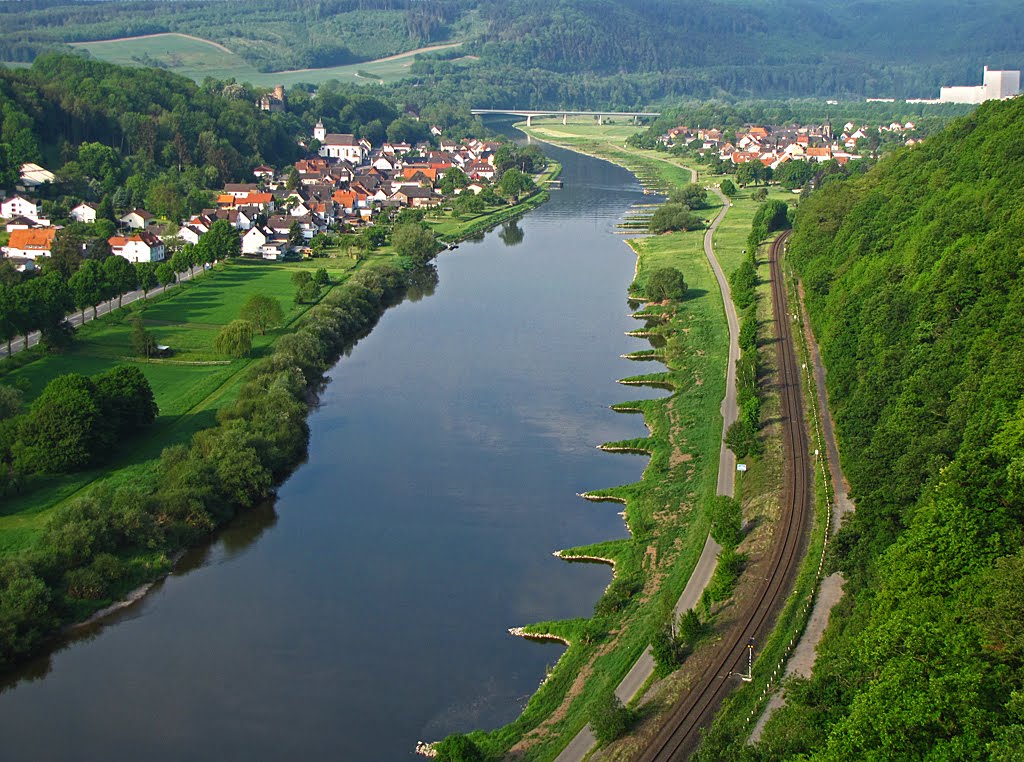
[{"left": 448, "top": 121, "right": 806, "bottom": 760}]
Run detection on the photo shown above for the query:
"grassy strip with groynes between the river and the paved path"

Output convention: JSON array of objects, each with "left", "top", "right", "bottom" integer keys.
[{"left": 436, "top": 123, "right": 728, "bottom": 759}]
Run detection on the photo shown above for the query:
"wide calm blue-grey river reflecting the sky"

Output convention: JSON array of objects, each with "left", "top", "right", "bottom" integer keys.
[{"left": 0, "top": 140, "right": 659, "bottom": 762}]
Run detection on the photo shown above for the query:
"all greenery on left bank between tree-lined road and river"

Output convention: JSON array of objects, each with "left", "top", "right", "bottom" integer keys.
[{"left": 0, "top": 153, "right": 557, "bottom": 666}]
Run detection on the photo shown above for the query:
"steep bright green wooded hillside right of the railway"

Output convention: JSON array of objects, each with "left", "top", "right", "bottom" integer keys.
[{"left": 752, "top": 92, "right": 1024, "bottom": 760}]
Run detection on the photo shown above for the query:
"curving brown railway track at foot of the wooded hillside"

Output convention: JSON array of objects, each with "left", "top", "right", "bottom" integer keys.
[{"left": 638, "top": 232, "right": 812, "bottom": 762}]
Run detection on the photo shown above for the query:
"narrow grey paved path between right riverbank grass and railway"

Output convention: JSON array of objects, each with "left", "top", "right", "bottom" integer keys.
[{"left": 555, "top": 186, "right": 739, "bottom": 762}]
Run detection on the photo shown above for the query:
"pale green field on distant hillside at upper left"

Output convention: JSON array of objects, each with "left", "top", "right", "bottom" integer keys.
[{"left": 73, "top": 33, "right": 468, "bottom": 87}]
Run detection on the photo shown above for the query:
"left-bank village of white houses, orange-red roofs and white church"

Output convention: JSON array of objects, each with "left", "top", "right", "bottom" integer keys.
[{"left": 0, "top": 122, "right": 516, "bottom": 271}]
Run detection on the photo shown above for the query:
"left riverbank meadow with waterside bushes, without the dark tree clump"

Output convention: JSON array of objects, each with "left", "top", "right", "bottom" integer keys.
[{"left": 0, "top": 178, "right": 577, "bottom": 666}]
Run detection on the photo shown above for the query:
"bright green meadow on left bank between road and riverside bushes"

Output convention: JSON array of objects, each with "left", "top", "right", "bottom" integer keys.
[{"left": 0, "top": 258, "right": 352, "bottom": 554}]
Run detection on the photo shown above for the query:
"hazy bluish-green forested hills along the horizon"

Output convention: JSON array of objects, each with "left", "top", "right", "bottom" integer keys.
[{"left": 0, "top": 0, "right": 1024, "bottom": 108}]
